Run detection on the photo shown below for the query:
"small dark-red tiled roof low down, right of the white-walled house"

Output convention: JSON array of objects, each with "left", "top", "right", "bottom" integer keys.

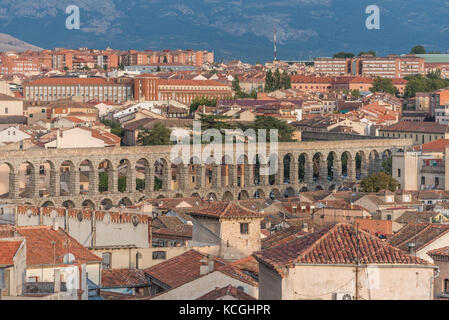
[{"left": 101, "top": 269, "right": 148, "bottom": 288}]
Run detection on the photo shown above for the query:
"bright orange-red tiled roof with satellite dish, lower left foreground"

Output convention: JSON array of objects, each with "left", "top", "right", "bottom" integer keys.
[{"left": 17, "top": 226, "right": 101, "bottom": 267}]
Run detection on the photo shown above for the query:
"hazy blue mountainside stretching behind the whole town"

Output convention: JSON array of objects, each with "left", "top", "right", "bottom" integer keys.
[{"left": 0, "top": 0, "right": 449, "bottom": 62}]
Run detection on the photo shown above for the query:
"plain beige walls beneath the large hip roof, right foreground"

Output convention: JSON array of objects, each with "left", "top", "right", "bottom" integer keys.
[{"left": 259, "top": 265, "right": 434, "bottom": 300}]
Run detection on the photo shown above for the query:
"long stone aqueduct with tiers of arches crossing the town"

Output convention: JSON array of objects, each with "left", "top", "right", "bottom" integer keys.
[{"left": 0, "top": 139, "right": 412, "bottom": 207}]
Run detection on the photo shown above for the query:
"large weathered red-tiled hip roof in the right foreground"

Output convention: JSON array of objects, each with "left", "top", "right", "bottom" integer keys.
[{"left": 254, "top": 223, "right": 429, "bottom": 273}]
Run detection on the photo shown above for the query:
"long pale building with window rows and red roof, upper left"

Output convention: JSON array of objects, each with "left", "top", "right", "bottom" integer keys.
[{"left": 24, "top": 77, "right": 133, "bottom": 103}]
